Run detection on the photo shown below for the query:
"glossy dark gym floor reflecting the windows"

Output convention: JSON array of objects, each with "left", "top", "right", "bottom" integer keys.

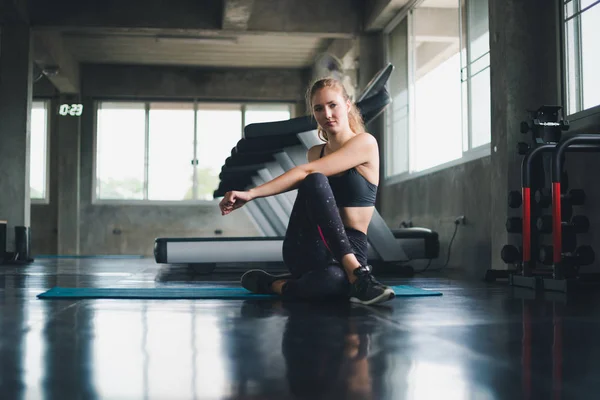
[{"left": 0, "top": 259, "right": 600, "bottom": 400}]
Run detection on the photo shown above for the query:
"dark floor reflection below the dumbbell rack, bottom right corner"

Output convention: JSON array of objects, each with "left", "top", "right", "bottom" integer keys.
[{"left": 513, "top": 290, "right": 600, "bottom": 400}]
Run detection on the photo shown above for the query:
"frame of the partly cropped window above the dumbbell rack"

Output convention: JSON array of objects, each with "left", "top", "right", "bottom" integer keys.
[{"left": 557, "top": 0, "right": 600, "bottom": 123}]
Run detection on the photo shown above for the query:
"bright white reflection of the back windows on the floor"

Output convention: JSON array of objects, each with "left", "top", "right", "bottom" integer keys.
[{"left": 91, "top": 302, "right": 229, "bottom": 399}]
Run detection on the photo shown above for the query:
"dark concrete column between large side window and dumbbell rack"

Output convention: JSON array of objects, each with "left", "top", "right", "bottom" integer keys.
[{"left": 489, "top": 0, "right": 562, "bottom": 269}]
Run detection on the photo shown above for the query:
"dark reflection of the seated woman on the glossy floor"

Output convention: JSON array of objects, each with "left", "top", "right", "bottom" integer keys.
[{"left": 236, "top": 301, "right": 380, "bottom": 400}]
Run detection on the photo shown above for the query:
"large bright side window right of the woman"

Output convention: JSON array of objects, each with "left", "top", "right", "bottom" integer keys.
[{"left": 385, "top": 0, "right": 491, "bottom": 178}]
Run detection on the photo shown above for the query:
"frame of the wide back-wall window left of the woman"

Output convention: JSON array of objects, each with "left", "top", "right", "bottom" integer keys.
[{"left": 91, "top": 98, "right": 295, "bottom": 206}]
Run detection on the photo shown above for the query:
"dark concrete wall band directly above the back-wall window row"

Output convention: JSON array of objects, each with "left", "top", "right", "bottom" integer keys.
[{"left": 81, "top": 64, "right": 309, "bottom": 102}]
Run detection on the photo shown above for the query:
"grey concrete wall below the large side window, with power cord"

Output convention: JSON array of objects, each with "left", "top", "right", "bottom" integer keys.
[{"left": 381, "top": 157, "right": 491, "bottom": 277}]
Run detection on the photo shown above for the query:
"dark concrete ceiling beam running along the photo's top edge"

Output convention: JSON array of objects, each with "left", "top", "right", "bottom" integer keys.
[{"left": 28, "top": 0, "right": 362, "bottom": 36}]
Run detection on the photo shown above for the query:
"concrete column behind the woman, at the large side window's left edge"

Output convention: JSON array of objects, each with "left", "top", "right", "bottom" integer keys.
[{"left": 357, "top": 34, "right": 385, "bottom": 209}]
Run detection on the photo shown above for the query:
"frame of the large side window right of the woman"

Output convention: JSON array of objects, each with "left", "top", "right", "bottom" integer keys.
[{"left": 383, "top": 0, "right": 492, "bottom": 185}]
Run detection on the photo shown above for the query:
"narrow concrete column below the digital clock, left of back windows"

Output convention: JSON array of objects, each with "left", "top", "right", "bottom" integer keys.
[{"left": 57, "top": 95, "right": 81, "bottom": 254}]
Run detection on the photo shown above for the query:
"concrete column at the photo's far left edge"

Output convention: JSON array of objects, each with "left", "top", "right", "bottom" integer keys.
[{"left": 0, "top": 21, "right": 32, "bottom": 251}]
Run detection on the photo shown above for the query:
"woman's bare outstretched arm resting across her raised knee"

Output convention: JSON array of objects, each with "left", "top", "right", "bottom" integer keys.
[{"left": 249, "top": 133, "right": 377, "bottom": 199}]
